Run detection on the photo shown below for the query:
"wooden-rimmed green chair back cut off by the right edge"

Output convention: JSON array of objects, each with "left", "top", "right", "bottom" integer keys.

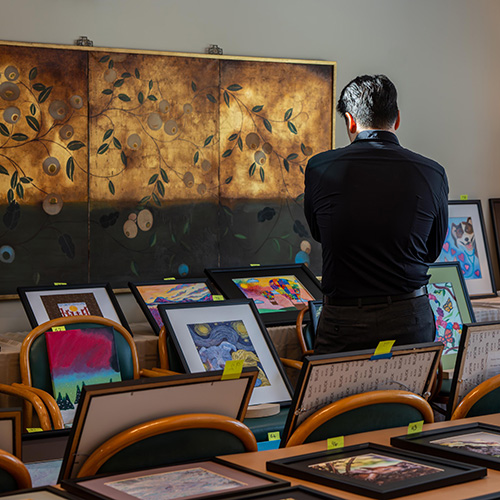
[{"left": 451, "top": 375, "right": 500, "bottom": 420}]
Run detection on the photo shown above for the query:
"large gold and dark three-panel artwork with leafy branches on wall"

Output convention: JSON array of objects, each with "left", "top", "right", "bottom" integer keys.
[{"left": 0, "top": 45, "right": 335, "bottom": 294}]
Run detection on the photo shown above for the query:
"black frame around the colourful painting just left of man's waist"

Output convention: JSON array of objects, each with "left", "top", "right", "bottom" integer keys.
[{"left": 205, "top": 264, "right": 323, "bottom": 326}]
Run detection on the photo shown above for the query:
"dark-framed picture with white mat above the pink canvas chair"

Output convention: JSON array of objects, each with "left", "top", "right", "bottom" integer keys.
[{"left": 17, "top": 283, "right": 130, "bottom": 331}]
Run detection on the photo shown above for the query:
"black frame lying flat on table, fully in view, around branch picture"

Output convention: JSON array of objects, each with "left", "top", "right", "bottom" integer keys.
[{"left": 266, "top": 443, "right": 487, "bottom": 500}]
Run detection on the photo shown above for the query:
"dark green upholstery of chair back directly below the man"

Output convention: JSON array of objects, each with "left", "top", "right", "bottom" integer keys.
[{"left": 304, "top": 403, "right": 423, "bottom": 443}]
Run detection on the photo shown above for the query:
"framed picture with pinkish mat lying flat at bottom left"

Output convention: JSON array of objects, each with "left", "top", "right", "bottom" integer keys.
[{"left": 62, "top": 458, "right": 290, "bottom": 500}]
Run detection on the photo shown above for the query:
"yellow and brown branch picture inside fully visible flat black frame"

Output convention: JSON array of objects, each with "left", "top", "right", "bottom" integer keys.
[{"left": 309, "top": 453, "right": 443, "bottom": 486}]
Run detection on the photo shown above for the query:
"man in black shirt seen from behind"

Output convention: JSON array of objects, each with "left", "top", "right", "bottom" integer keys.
[{"left": 304, "top": 75, "right": 448, "bottom": 354}]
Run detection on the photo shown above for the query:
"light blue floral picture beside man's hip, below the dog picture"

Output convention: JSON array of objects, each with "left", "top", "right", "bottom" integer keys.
[{"left": 427, "top": 283, "right": 463, "bottom": 354}]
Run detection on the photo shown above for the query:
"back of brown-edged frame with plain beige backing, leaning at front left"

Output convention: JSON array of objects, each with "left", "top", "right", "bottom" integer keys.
[{"left": 58, "top": 369, "right": 257, "bottom": 482}]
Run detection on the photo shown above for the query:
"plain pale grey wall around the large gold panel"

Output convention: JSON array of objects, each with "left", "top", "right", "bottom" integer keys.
[{"left": 0, "top": 0, "right": 500, "bottom": 331}]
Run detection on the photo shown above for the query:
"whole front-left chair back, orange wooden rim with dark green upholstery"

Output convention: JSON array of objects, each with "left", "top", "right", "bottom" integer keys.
[{"left": 78, "top": 413, "right": 257, "bottom": 477}]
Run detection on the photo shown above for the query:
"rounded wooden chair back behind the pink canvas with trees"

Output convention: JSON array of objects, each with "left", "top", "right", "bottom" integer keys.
[{"left": 19, "top": 316, "right": 139, "bottom": 394}]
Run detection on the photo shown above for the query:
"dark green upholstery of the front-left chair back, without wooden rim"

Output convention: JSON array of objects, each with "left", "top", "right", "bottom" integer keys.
[{"left": 98, "top": 429, "right": 246, "bottom": 474}]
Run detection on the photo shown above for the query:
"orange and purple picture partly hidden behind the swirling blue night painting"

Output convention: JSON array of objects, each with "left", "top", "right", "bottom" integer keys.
[{"left": 137, "top": 283, "right": 212, "bottom": 328}]
